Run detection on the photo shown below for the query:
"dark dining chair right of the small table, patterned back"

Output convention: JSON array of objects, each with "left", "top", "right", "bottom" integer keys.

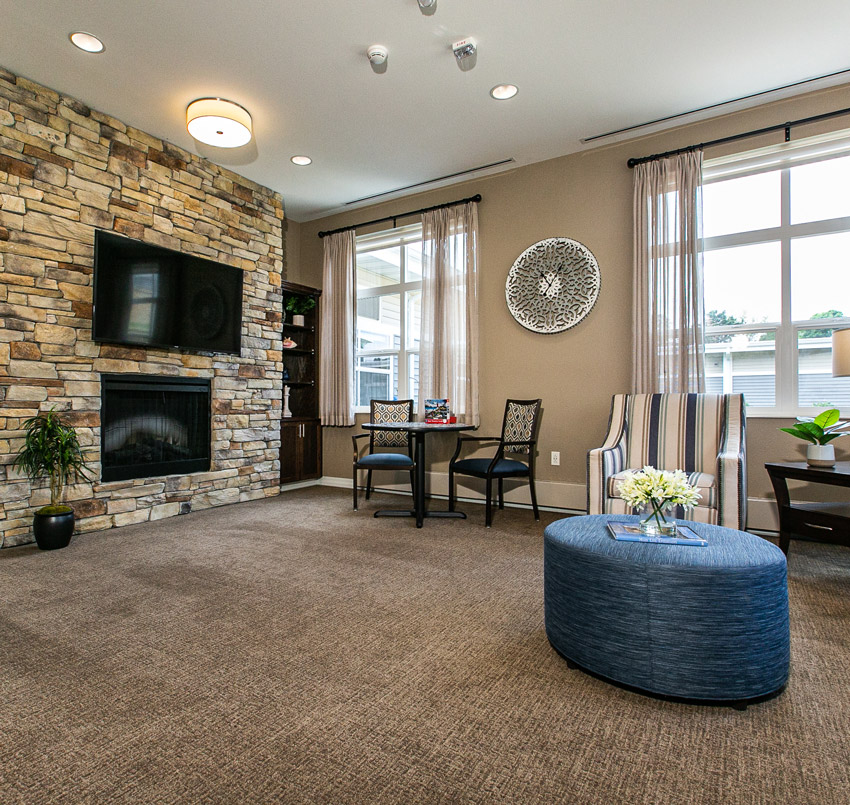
[{"left": 449, "top": 400, "right": 542, "bottom": 528}]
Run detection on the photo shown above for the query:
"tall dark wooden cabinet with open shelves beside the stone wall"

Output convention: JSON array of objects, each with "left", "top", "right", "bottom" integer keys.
[{"left": 280, "top": 282, "right": 322, "bottom": 484}]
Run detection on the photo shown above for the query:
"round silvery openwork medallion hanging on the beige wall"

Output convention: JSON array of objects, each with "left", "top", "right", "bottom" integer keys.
[{"left": 505, "top": 238, "right": 601, "bottom": 333}]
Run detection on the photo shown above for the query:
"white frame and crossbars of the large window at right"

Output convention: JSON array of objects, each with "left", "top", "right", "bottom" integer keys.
[{"left": 701, "top": 132, "right": 850, "bottom": 418}]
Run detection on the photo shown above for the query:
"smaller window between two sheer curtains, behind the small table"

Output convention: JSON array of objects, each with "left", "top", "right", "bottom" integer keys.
[{"left": 354, "top": 224, "right": 422, "bottom": 412}]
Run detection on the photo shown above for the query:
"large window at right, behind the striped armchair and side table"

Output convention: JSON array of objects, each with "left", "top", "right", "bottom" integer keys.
[{"left": 703, "top": 132, "right": 850, "bottom": 416}]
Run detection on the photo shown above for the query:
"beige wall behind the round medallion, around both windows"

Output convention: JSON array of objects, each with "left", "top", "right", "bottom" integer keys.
[{"left": 288, "top": 80, "right": 850, "bottom": 527}]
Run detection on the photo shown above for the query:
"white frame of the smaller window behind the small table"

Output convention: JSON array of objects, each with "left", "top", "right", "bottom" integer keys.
[{"left": 354, "top": 223, "right": 422, "bottom": 414}]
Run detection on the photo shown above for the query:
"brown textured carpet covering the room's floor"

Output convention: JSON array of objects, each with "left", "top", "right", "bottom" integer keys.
[{"left": 0, "top": 488, "right": 850, "bottom": 805}]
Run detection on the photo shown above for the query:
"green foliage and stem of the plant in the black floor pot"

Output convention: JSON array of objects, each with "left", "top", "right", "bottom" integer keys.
[{"left": 12, "top": 410, "right": 88, "bottom": 514}]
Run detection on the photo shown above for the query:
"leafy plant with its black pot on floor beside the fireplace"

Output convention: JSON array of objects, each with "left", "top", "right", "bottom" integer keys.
[{"left": 12, "top": 410, "right": 87, "bottom": 551}]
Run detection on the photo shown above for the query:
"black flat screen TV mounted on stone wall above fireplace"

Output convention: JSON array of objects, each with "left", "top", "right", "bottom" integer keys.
[{"left": 92, "top": 230, "right": 242, "bottom": 355}]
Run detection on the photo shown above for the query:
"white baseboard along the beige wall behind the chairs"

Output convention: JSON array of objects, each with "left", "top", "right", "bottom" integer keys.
[{"left": 290, "top": 472, "right": 779, "bottom": 534}]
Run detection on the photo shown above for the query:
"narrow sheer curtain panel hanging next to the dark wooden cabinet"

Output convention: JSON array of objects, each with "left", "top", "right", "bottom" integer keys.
[{"left": 319, "top": 229, "right": 357, "bottom": 425}]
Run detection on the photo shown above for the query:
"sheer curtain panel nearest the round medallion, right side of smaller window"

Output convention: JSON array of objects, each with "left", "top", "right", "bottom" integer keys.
[{"left": 419, "top": 202, "right": 479, "bottom": 425}]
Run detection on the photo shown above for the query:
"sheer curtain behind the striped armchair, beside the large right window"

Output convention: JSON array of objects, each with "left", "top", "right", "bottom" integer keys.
[{"left": 632, "top": 151, "right": 705, "bottom": 394}]
